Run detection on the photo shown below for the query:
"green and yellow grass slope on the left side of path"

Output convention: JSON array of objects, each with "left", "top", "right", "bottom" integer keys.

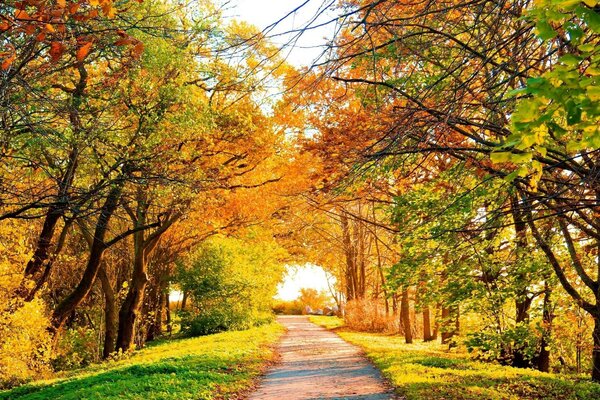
[{"left": 0, "top": 323, "right": 283, "bottom": 400}]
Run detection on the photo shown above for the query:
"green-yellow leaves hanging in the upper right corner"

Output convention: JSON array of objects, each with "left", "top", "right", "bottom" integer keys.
[{"left": 506, "top": 0, "right": 600, "bottom": 159}]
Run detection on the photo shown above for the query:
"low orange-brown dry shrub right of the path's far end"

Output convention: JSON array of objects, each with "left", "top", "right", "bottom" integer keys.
[{"left": 344, "top": 300, "right": 398, "bottom": 333}]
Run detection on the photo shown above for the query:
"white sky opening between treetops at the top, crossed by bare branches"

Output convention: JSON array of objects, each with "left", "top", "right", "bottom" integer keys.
[{"left": 225, "top": 0, "right": 334, "bottom": 66}]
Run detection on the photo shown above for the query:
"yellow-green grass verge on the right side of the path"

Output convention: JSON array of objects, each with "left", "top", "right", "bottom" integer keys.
[{"left": 311, "top": 316, "right": 600, "bottom": 400}]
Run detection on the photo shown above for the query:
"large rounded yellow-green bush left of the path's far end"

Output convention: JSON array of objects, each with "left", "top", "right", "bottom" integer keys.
[{"left": 176, "top": 238, "right": 282, "bottom": 336}]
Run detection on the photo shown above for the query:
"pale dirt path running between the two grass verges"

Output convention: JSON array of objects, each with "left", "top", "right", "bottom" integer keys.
[{"left": 249, "top": 316, "right": 395, "bottom": 400}]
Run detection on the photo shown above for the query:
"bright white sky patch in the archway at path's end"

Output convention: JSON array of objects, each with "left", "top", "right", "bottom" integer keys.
[{"left": 275, "top": 264, "right": 334, "bottom": 300}]
